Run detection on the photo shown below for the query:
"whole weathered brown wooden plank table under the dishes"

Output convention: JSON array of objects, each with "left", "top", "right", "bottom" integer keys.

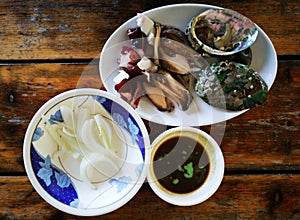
[{"left": 0, "top": 0, "right": 300, "bottom": 219}]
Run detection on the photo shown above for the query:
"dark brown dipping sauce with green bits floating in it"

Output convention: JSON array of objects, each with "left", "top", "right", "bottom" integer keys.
[{"left": 153, "top": 136, "right": 210, "bottom": 194}]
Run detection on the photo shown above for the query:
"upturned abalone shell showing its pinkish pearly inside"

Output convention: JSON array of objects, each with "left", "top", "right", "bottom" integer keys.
[{"left": 186, "top": 9, "right": 258, "bottom": 55}]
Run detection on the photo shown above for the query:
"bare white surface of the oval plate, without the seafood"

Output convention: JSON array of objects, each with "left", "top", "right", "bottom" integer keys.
[{"left": 99, "top": 4, "right": 277, "bottom": 126}]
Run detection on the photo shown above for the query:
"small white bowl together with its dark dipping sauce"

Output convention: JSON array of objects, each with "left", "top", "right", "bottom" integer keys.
[{"left": 147, "top": 127, "right": 225, "bottom": 206}]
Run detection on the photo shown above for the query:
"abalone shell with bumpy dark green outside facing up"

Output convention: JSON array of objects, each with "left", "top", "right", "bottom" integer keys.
[{"left": 195, "top": 61, "right": 268, "bottom": 110}]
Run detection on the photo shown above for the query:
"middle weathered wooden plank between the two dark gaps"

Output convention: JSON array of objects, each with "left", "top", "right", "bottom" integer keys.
[{"left": 0, "top": 61, "right": 300, "bottom": 172}]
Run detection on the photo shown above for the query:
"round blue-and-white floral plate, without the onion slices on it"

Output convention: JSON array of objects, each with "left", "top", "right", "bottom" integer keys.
[{"left": 23, "top": 89, "right": 150, "bottom": 216}]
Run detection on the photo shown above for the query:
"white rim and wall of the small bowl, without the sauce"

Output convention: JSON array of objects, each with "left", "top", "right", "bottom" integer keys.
[{"left": 147, "top": 127, "right": 224, "bottom": 206}]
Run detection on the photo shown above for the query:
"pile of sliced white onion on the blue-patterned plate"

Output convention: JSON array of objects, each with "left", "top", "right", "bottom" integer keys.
[{"left": 45, "top": 101, "right": 124, "bottom": 189}]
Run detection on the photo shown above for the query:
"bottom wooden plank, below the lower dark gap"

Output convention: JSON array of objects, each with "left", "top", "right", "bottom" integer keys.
[{"left": 0, "top": 175, "right": 300, "bottom": 219}]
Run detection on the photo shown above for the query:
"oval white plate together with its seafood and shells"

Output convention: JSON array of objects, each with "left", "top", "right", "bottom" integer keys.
[{"left": 99, "top": 4, "right": 277, "bottom": 126}]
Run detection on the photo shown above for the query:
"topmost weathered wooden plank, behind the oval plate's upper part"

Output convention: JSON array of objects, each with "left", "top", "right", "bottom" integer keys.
[{"left": 0, "top": 0, "right": 300, "bottom": 60}]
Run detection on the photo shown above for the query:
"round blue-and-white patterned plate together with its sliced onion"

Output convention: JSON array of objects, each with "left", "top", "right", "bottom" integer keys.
[{"left": 23, "top": 89, "right": 150, "bottom": 216}]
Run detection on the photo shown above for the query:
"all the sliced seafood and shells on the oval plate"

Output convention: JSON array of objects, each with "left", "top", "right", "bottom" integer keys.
[{"left": 112, "top": 9, "right": 268, "bottom": 112}]
